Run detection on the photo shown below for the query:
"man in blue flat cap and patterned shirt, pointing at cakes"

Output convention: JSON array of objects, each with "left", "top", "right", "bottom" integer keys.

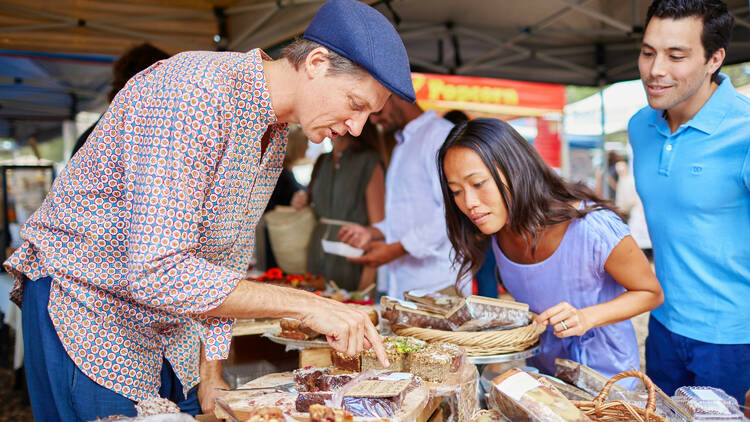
[{"left": 4, "top": 0, "right": 414, "bottom": 421}]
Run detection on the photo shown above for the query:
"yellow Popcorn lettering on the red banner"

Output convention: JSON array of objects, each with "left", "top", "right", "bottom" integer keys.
[{"left": 420, "top": 77, "right": 520, "bottom": 105}]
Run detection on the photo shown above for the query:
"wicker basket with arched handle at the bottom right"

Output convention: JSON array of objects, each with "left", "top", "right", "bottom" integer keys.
[{"left": 573, "top": 371, "right": 666, "bottom": 422}]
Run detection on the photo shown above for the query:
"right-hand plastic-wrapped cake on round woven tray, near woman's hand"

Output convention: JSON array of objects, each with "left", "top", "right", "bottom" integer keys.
[{"left": 446, "top": 296, "right": 531, "bottom": 331}]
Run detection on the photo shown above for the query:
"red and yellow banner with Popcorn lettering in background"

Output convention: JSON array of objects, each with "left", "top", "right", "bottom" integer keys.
[{"left": 411, "top": 73, "right": 565, "bottom": 116}]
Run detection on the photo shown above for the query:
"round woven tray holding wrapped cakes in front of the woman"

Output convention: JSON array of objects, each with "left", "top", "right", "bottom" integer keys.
[{"left": 391, "top": 324, "right": 547, "bottom": 357}]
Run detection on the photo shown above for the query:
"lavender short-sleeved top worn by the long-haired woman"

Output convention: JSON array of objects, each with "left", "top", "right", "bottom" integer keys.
[{"left": 491, "top": 204, "right": 640, "bottom": 387}]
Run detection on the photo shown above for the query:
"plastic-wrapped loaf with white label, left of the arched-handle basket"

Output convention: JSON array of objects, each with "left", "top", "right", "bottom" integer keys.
[{"left": 489, "top": 368, "right": 591, "bottom": 422}]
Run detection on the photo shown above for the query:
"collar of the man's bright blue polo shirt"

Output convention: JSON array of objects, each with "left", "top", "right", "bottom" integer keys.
[{"left": 649, "top": 73, "right": 736, "bottom": 135}]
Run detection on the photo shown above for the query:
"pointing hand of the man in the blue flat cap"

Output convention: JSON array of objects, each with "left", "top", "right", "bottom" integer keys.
[{"left": 302, "top": 298, "right": 390, "bottom": 367}]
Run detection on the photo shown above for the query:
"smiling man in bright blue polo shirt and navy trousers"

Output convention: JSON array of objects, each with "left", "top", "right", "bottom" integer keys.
[{"left": 628, "top": 0, "right": 750, "bottom": 403}]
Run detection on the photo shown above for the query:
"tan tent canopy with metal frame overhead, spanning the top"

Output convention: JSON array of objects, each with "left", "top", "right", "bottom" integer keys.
[{"left": 0, "top": 0, "right": 750, "bottom": 85}]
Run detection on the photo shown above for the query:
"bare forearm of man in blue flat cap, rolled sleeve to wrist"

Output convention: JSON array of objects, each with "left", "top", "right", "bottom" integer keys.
[{"left": 205, "top": 280, "right": 320, "bottom": 319}]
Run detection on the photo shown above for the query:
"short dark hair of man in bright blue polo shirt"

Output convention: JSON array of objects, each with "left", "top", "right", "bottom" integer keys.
[{"left": 644, "top": 0, "right": 734, "bottom": 83}]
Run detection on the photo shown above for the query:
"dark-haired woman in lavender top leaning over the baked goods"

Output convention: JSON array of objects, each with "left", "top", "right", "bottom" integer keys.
[{"left": 438, "top": 119, "right": 663, "bottom": 382}]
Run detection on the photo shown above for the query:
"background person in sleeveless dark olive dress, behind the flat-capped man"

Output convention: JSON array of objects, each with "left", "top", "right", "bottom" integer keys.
[{"left": 292, "top": 122, "right": 385, "bottom": 291}]
